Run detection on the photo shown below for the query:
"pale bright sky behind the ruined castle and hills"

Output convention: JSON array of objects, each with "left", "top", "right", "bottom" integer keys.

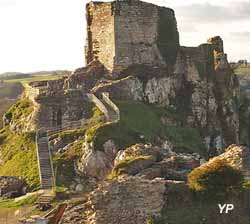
[{"left": 0, "top": 0, "right": 250, "bottom": 73}]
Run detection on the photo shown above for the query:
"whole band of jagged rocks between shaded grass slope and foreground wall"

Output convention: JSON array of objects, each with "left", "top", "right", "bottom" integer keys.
[{"left": 75, "top": 140, "right": 200, "bottom": 180}]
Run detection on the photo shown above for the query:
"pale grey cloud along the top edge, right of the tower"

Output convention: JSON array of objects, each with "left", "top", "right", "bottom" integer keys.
[{"left": 176, "top": 1, "right": 250, "bottom": 23}]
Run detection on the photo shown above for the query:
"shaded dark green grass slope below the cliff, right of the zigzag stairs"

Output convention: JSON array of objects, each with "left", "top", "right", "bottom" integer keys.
[{"left": 87, "top": 102, "right": 204, "bottom": 156}]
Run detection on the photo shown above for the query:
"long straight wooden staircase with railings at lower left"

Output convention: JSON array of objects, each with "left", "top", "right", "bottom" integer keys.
[{"left": 36, "top": 130, "right": 55, "bottom": 204}]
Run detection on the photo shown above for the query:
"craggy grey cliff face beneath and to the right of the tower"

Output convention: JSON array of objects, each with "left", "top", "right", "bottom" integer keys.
[{"left": 92, "top": 39, "right": 240, "bottom": 155}]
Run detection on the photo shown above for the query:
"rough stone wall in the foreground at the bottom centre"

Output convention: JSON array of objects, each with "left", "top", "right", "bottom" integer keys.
[{"left": 63, "top": 177, "right": 166, "bottom": 224}]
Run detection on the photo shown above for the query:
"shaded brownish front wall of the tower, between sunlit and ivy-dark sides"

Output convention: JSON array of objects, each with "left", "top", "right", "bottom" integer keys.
[{"left": 115, "top": 1, "right": 165, "bottom": 71}]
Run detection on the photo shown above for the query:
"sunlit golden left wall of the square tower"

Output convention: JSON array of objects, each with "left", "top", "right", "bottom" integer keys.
[{"left": 85, "top": 2, "right": 115, "bottom": 70}]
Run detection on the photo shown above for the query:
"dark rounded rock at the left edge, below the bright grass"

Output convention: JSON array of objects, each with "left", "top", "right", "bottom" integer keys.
[{"left": 0, "top": 176, "right": 27, "bottom": 198}]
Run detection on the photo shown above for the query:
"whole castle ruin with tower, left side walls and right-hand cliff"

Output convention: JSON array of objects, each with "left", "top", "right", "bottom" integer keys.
[{"left": 6, "top": 0, "right": 240, "bottom": 157}]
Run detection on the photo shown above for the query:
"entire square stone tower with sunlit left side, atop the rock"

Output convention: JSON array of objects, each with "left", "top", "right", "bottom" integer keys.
[{"left": 85, "top": 0, "right": 179, "bottom": 73}]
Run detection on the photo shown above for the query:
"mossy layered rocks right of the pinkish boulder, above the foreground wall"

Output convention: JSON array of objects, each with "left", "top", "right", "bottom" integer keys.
[{"left": 113, "top": 144, "right": 200, "bottom": 181}]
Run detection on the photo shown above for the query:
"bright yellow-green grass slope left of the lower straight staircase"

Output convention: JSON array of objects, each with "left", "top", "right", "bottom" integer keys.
[{"left": 0, "top": 128, "right": 40, "bottom": 189}]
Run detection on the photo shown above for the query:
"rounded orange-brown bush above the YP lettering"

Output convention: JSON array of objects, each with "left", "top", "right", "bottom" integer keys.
[{"left": 188, "top": 159, "right": 243, "bottom": 195}]
